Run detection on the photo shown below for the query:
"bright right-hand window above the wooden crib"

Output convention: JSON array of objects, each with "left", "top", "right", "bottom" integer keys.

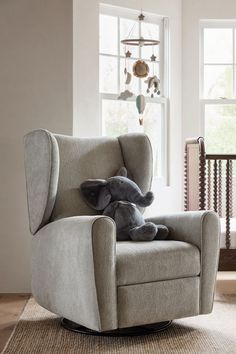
[{"left": 200, "top": 21, "right": 236, "bottom": 154}]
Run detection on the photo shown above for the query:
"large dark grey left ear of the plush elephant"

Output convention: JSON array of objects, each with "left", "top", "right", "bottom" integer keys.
[{"left": 80, "top": 179, "right": 111, "bottom": 210}]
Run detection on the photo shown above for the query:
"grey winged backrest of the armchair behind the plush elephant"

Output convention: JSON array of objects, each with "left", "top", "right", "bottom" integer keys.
[{"left": 25, "top": 130, "right": 152, "bottom": 234}]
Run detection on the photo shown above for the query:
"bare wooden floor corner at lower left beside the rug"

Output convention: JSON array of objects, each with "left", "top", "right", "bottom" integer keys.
[{"left": 0, "top": 294, "right": 30, "bottom": 353}]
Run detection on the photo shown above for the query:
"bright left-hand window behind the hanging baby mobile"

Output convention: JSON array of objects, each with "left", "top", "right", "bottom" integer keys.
[{"left": 99, "top": 5, "right": 168, "bottom": 179}]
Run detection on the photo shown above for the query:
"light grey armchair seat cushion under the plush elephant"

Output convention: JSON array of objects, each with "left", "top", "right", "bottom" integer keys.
[{"left": 116, "top": 240, "right": 200, "bottom": 285}]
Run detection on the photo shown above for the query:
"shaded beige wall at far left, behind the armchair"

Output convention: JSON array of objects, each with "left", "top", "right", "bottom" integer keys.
[{"left": 0, "top": 0, "right": 73, "bottom": 293}]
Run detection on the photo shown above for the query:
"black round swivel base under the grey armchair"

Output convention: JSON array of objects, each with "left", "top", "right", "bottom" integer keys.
[{"left": 61, "top": 318, "right": 172, "bottom": 337}]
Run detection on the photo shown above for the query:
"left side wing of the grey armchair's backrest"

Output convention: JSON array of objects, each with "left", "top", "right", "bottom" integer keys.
[{"left": 24, "top": 130, "right": 59, "bottom": 234}]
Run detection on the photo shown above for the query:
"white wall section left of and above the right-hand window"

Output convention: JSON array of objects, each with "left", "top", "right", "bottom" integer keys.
[{"left": 182, "top": 0, "right": 236, "bottom": 139}]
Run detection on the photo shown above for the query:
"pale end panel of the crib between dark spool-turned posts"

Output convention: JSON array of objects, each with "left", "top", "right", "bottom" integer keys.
[{"left": 184, "top": 137, "right": 205, "bottom": 210}]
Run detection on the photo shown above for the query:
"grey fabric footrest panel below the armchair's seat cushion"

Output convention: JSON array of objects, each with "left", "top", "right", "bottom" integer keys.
[{"left": 117, "top": 277, "right": 199, "bottom": 328}]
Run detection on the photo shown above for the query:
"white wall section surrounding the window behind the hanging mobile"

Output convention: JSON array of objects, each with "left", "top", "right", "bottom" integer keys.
[{"left": 74, "top": 0, "right": 183, "bottom": 215}]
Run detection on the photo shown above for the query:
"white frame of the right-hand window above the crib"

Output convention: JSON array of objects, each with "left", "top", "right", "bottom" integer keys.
[{"left": 199, "top": 20, "right": 236, "bottom": 136}]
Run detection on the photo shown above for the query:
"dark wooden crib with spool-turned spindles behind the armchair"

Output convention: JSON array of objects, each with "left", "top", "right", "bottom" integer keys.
[{"left": 184, "top": 137, "right": 236, "bottom": 271}]
